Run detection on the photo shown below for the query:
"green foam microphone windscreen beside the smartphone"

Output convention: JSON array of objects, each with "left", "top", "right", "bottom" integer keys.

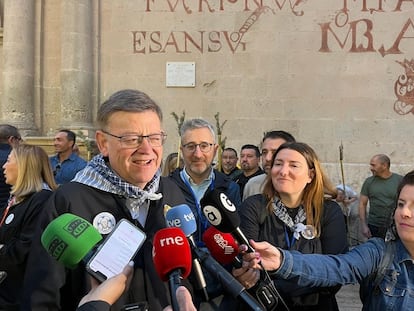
[{"left": 41, "top": 213, "right": 102, "bottom": 268}]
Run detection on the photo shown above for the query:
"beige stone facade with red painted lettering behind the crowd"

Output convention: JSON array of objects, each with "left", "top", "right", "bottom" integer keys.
[{"left": 0, "top": 0, "right": 414, "bottom": 190}]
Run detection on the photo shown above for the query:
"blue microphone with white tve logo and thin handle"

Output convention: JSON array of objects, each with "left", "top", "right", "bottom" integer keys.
[{"left": 165, "top": 204, "right": 209, "bottom": 301}]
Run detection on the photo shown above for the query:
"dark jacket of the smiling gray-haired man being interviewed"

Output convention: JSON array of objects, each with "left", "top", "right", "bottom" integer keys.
[{"left": 21, "top": 178, "right": 185, "bottom": 311}]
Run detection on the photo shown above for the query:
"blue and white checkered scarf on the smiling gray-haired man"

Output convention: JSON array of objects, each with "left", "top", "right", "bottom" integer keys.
[{"left": 73, "top": 154, "right": 162, "bottom": 214}]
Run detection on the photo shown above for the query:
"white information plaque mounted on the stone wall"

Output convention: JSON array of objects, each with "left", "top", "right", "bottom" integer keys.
[{"left": 165, "top": 62, "right": 195, "bottom": 87}]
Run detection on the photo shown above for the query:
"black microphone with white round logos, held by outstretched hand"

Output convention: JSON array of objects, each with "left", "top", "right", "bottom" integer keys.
[{"left": 200, "top": 189, "right": 254, "bottom": 253}]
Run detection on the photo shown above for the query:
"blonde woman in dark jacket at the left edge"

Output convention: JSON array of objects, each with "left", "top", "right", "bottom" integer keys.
[{"left": 0, "top": 144, "right": 57, "bottom": 310}]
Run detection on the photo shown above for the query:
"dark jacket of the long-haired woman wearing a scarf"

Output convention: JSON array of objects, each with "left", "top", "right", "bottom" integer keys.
[{"left": 239, "top": 194, "right": 348, "bottom": 311}]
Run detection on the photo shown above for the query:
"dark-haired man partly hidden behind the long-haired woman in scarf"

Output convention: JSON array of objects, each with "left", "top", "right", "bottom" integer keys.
[{"left": 243, "top": 131, "right": 295, "bottom": 200}]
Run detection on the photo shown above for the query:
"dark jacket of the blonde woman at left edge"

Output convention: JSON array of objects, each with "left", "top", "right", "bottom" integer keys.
[{"left": 0, "top": 190, "right": 52, "bottom": 310}]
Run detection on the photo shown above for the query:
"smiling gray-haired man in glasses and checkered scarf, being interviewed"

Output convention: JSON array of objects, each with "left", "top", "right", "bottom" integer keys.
[{"left": 22, "top": 90, "right": 185, "bottom": 311}]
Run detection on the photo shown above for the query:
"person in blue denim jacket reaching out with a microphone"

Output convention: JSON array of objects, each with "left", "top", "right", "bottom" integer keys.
[{"left": 242, "top": 171, "right": 414, "bottom": 311}]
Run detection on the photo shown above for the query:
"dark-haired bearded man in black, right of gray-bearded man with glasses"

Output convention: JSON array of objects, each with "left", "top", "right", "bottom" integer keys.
[{"left": 235, "top": 144, "right": 264, "bottom": 198}]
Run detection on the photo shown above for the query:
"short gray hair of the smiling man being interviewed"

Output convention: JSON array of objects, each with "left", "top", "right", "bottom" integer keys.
[{"left": 97, "top": 89, "right": 162, "bottom": 129}]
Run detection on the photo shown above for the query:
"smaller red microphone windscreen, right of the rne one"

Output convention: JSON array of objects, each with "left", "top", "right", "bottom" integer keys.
[{"left": 203, "top": 226, "right": 239, "bottom": 264}]
